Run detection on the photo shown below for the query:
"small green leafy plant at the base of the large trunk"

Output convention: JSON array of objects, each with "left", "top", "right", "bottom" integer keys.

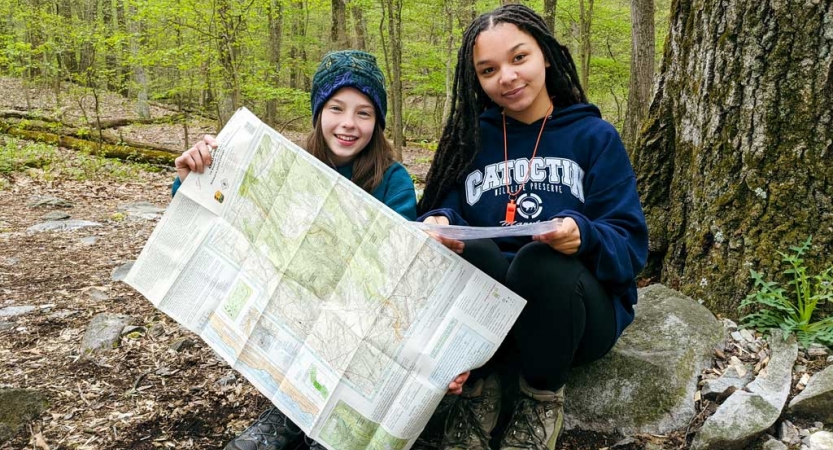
[{"left": 740, "top": 236, "right": 833, "bottom": 348}]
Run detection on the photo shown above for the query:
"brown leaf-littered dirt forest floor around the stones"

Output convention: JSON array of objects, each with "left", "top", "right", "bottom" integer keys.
[{"left": 0, "top": 79, "right": 828, "bottom": 450}]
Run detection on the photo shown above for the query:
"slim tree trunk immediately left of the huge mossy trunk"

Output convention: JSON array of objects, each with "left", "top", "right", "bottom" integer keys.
[{"left": 622, "top": 0, "right": 656, "bottom": 152}]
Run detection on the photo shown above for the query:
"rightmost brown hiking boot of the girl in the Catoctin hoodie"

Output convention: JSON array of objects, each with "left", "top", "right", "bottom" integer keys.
[{"left": 500, "top": 377, "right": 564, "bottom": 450}]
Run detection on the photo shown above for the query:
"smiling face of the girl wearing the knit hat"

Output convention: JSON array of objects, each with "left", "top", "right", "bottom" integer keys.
[{"left": 321, "top": 87, "right": 376, "bottom": 167}]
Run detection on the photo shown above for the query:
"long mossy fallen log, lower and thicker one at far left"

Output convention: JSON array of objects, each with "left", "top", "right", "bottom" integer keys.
[{"left": 0, "top": 120, "right": 180, "bottom": 166}]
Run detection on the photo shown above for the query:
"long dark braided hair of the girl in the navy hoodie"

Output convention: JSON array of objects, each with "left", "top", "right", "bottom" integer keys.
[{"left": 418, "top": 4, "right": 587, "bottom": 214}]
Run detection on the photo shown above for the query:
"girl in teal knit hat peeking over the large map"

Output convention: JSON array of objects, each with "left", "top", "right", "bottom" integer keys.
[{"left": 172, "top": 50, "right": 416, "bottom": 222}]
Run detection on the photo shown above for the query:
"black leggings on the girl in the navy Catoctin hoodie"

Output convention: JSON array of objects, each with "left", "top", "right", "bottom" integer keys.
[{"left": 462, "top": 239, "right": 616, "bottom": 391}]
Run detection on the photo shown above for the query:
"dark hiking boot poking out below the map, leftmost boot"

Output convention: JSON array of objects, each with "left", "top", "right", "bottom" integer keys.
[{"left": 225, "top": 406, "right": 303, "bottom": 450}]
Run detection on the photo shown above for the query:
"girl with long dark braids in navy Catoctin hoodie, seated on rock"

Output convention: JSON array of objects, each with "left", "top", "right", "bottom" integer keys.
[{"left": 418, "top": 4, "right": 648, "bottom": 450}]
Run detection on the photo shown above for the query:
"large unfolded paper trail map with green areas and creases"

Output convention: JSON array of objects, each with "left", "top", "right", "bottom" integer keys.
[{"left": 126, "top": 109, "right": 524, "bottom": 450}]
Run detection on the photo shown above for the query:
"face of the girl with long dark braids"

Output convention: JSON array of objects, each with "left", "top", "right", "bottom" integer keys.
[{"left": 473, "top": 23, "right": 550, "bottom": 123}]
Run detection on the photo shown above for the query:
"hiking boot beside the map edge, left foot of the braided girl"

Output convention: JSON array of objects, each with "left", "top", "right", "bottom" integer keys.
[{"left": 440, "top": 374, "right": 501, "bottom": 450}]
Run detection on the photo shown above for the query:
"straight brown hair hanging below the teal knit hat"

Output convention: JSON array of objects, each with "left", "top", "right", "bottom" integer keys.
[{"left": 306, "top": 118, "right": 393, "bottom": 194}]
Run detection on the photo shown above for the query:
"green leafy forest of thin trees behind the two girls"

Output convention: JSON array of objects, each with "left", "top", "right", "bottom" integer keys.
[{"left": 0, "top": 0, "right": 670, "bottom": 154}]
